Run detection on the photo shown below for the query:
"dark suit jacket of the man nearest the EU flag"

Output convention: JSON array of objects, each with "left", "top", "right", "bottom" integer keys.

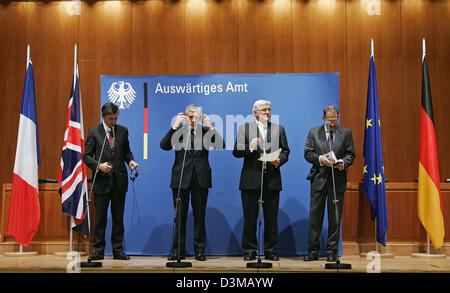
[{"left": 304, "top": 125, "right": 355, "bottom": 192}]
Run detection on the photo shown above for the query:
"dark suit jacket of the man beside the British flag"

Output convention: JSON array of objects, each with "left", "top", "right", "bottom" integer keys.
[{"left": 83, "top": 123, "right": 134, "bottom": 193}]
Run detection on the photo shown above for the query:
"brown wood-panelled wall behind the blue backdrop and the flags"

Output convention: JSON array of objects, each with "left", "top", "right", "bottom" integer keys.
[{"left": 0, "top": 0, "right": 450, "bottom": 245}]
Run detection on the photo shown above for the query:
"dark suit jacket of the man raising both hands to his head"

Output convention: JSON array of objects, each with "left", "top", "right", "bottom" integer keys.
[{"left": 160, "top": 124, "right": 225, "bottom": 189}]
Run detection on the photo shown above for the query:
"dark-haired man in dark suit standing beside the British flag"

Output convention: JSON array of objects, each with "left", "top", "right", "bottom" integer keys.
[{"left": 83, "top": 103, "right": 139, "bottom": 260}]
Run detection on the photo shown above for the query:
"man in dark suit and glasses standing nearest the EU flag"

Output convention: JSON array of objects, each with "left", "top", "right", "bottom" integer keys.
[{"left": 304, "top": 106, "right": 355, "bottom": 262}]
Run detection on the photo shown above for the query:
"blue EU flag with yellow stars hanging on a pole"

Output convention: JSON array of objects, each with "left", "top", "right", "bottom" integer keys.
[{"left": 363, "top": 56, "right": 388, "bottom": 246}]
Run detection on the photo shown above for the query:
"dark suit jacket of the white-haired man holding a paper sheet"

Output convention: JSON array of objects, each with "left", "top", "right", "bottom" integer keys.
[{"left": 233, "top": 122, "right": 290, "bottom": 190}]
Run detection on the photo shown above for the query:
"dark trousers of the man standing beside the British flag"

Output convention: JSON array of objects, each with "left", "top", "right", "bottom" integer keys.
[{"left": 94, "top": 188, "right": 125, "bottom": 253}]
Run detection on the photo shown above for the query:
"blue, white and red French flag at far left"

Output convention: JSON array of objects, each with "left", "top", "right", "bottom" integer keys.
[{"left": 6, "top": 61, "right": 41, "bottom": 246}]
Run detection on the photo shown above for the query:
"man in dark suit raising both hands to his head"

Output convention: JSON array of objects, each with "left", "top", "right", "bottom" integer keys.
[{"left": 160, "top": 105, "right": 225, "bottom": 261}]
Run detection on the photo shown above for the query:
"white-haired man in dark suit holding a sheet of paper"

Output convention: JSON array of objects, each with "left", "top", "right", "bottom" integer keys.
[{"left": 233, "top": 100, "right": 290, "bottom": 261}]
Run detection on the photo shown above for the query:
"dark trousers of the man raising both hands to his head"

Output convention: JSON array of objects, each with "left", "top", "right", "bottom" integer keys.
[{"left": 172, "top": 180, "right": 208, "bottom": 255}]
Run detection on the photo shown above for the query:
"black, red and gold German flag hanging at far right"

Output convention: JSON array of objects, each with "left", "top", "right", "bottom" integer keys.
[{"left": 417, "top": 56, "right": 445, "bottom": 248}]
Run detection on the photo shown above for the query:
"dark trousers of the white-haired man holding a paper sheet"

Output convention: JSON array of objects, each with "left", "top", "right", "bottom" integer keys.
[{"left": 241, "top": 188, "right": 280, "bottom": 255}]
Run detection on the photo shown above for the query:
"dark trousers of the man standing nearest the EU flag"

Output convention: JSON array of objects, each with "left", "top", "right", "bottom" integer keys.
[{"left": 308, "top": 178, "right": 344, "bottom": 253}]
